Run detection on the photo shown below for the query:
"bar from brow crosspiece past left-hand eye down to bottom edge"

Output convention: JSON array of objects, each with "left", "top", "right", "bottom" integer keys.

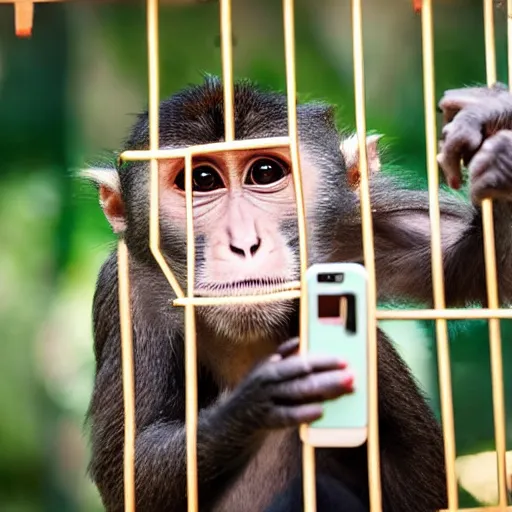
[{"left": 185, "top": 154, "right": 199, "bottom": 512}]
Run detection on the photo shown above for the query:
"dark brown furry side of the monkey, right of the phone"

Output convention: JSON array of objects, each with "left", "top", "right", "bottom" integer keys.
[{"left": 378, "top": 332, "right": 447, "bottom": 512}]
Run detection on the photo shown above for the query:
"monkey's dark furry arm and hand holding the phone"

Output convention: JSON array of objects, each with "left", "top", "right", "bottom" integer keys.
[{"left": 89, "top": 255, "right": 352, "bottom": 512}]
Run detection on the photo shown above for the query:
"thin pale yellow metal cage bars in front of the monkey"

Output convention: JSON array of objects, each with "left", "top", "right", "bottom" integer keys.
[{"left": 0, "top": 0, "right": 512, "bottom": 512}]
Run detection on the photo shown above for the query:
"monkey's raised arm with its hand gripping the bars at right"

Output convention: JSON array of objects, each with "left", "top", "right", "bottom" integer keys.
[{"left": 340, "top": 85, "right": 512, "bottom": 306}]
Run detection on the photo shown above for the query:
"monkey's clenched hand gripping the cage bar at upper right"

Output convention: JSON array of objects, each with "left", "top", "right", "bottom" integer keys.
[{"left": 438, "top": 84, "right": 512, "bottom": 204}]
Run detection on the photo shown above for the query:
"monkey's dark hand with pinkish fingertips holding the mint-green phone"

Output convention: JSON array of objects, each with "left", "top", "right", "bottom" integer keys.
[{"left": 222, "top": 339, "right": 353, "bottom": 429}]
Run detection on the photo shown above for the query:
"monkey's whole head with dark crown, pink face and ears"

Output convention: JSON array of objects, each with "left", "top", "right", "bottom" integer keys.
[{"left": 87, "top": 78, "right": 378, "bottom": 342}]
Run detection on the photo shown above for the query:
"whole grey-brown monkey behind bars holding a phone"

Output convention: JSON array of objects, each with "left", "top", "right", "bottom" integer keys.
[{"left": 83, "top": 75, "right": 512, "bottom": 512}]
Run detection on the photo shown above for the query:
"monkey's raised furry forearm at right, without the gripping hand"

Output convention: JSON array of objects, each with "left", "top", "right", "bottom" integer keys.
[{"left": 366, "top": 174, "right": 512, "bottom": 307}]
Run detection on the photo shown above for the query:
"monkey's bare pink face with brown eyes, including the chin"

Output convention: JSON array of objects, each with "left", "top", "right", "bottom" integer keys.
[{"left": 160, "top": 149, "right": 320, "bottom": 339}]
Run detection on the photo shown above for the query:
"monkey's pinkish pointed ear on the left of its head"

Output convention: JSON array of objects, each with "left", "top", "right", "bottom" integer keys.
[{"left": 80, "top": 168, "right": 126, "bottom": 234}]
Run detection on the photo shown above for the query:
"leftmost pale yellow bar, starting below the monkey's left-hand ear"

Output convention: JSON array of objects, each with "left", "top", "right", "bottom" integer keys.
[{"left": 117, "top": 240, "right": 135, "bottom": 512}]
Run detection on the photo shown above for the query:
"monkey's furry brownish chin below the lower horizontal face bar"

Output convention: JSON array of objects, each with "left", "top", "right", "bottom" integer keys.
[{"left": 196, "top": 300, "right": 294, "bottom": 343}]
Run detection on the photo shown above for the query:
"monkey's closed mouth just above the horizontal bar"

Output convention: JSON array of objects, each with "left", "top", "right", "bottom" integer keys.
[{"left": 195, "top": 277, "right": 294, "bottom": 297}]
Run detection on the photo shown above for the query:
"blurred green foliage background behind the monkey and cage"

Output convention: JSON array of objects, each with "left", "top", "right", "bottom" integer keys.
[{"left": 0, "top": 0, "right": 512, "bottom": 512}]
